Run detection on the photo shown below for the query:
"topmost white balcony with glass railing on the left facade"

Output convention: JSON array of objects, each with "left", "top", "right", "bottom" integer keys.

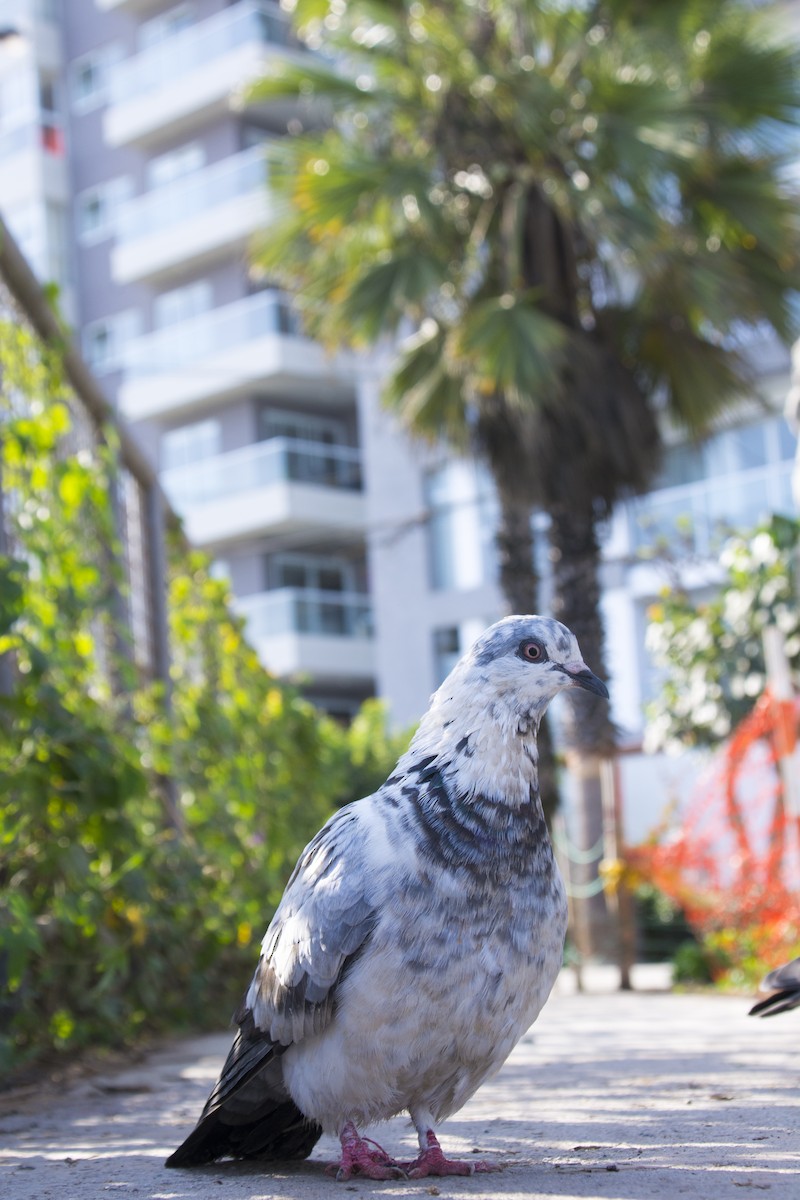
[{"left": 104, "top": 0, "right": 302, "bottom": 146}]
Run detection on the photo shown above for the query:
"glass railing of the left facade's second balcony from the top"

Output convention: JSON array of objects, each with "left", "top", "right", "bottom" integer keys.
[{"left": 116, "top": 146, "right": 266, "bottom": 241}]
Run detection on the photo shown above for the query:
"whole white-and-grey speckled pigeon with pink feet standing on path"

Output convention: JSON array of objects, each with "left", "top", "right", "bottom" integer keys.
[{"left": 167, "top": 616, "right": 608, "bottom": 1180}]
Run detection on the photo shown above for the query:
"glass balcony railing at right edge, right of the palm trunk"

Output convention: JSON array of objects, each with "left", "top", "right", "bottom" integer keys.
[{"left": 632, "top": 460, "right": 795, "bottom": 556}]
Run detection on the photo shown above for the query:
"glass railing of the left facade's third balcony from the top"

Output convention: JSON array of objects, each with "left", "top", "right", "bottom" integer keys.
[{"left": 125, "top": 292, "right": 300, "bottom": 377}]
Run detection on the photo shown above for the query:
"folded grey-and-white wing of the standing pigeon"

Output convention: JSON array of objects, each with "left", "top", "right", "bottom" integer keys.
[{"left": 208, "top": 802, "right": 378, "bottom": 1116}]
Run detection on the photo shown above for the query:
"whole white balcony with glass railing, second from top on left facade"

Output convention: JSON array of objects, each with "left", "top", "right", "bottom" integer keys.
[{"left": 112, "top": 146, "right": 269, "bottom": 283}]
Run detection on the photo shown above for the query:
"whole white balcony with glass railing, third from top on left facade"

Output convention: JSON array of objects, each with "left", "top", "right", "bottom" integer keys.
[{"left": 119, "top": 292, "right": 353, "bottom": 421}]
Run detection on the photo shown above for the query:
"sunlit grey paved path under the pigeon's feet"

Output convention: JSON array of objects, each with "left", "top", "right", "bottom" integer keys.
[{"left": 0, "top": 983, "right": 800, "bottom": 1200}]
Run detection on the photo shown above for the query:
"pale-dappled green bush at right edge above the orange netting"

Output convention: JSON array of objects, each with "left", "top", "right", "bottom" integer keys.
[{"left": 646, "top": 517, "right": 800, "bottom": 750}]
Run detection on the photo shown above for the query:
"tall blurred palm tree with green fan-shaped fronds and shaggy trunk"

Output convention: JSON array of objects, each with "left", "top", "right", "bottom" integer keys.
[{"left": 255, "top": 0, "right": 800, "bottom": 955}]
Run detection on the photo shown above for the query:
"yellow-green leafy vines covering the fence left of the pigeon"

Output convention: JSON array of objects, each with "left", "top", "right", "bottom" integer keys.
[{"left": 0, "top": 322, "right": 404, "bottom": 1068}]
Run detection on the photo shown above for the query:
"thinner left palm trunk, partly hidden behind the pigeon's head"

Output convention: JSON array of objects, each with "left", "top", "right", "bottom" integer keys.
[{"left": 495, "top": 480, "right": 559, "bottom": 824}]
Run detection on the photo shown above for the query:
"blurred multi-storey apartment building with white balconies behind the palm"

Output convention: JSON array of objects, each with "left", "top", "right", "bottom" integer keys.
[{"left": 0, "top": 0, "right": 795, "bottom": 836}]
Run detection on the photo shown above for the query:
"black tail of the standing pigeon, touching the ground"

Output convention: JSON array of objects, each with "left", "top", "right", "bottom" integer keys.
[{"left": 166, "top": 1013, "right": 323, "bottom": 1166}]
